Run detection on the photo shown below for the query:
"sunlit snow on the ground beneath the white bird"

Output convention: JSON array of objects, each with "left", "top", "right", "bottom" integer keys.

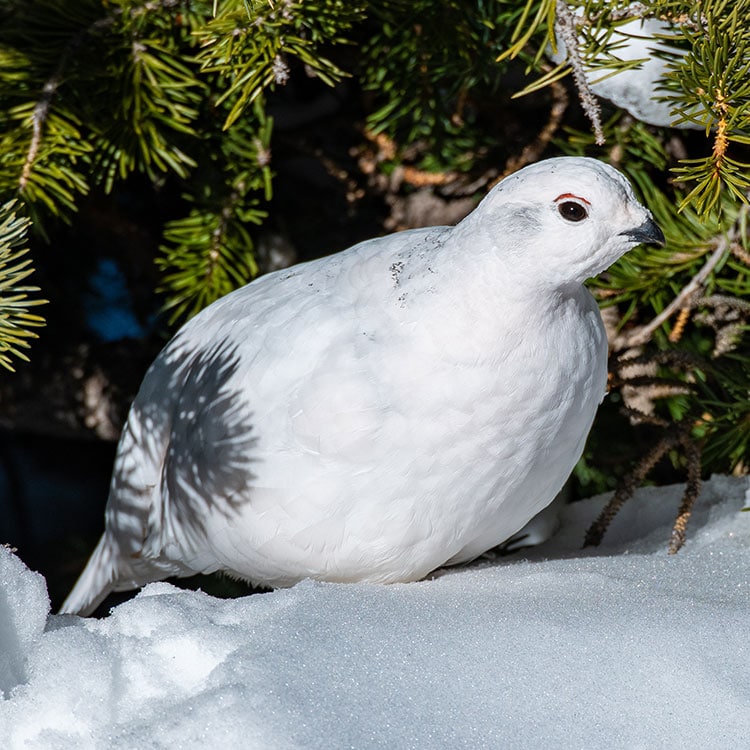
[{"left": 0, "top": 477, "right": 750, "bottom": 750}]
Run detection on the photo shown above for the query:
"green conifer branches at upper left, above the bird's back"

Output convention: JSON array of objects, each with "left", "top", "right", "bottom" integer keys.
[{"left": 0, "top": 0, "right": 359, "bottom": 319}]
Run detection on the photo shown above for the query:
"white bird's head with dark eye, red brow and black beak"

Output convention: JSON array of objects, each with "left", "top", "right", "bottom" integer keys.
[{"left": 468, "top": 157, "right": 664, "bottom": 285}]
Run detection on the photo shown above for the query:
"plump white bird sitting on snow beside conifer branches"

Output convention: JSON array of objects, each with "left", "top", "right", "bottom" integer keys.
[{"left": 62, "top": 157, "right": 664, "bottom": 613}]
